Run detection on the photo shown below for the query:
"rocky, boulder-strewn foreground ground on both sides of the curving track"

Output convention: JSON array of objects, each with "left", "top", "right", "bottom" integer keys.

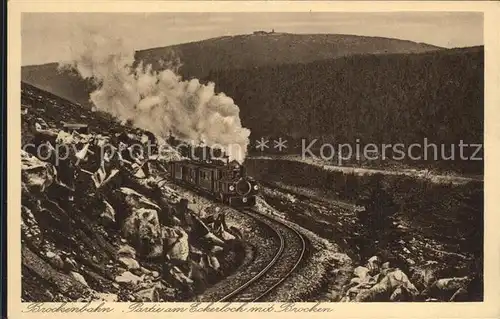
[{"left": 21, "top": 83, "right": 483, "bottom": 302}]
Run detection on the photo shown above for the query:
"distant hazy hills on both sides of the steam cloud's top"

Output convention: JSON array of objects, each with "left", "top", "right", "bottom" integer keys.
[{"left": 21, "top": 33, "right": 440, "bottom": 104}]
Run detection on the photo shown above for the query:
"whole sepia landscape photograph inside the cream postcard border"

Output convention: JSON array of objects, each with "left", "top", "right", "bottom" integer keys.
[{"left": 16, "top": 10, "right": 488, "bottom": 312}]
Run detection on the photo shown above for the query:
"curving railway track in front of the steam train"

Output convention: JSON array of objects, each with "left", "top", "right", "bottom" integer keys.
[{"left": 217, "top": 209, "right": 306, "bottom": 302}]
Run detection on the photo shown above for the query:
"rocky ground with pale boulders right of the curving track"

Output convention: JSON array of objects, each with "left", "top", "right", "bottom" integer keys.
[{"left": 262, "top": 184, "right": 483, "bottom": 302}]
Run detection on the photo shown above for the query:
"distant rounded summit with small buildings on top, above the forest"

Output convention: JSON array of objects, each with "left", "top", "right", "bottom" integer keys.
[{"left": 136, "top": 33, "right": 440, "bottom": 78}]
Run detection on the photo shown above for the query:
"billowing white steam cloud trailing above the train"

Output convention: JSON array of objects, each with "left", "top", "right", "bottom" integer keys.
[{"left": 60, "top": 32, "right": 250, "bottom": 163}]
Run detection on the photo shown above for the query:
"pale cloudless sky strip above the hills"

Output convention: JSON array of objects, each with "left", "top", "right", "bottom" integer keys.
[{"left": 21, "top": 12, "right": 484, "bottom": 65}]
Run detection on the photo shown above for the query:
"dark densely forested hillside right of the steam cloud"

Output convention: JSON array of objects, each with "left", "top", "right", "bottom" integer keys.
[{"left": 214, "top": 47, "right": 484, "bottom": 173}]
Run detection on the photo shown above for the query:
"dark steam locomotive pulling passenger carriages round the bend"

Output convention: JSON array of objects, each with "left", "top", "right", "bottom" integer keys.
[{"left": 168, "top": 159, "right": 259, "bottom": 207}]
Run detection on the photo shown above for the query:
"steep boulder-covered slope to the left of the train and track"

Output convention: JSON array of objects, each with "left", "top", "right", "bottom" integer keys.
[{"left": 21, "top": 82, "right": 244, "bottom": 301}]
